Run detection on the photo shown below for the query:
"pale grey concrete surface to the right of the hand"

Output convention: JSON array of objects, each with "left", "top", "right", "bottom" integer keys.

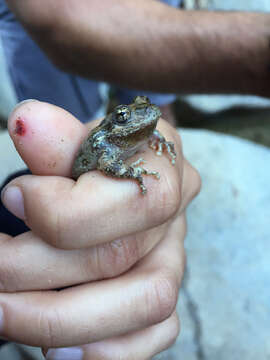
[{"left": 155, "top": 130, "right": 270, "bottom": 360}]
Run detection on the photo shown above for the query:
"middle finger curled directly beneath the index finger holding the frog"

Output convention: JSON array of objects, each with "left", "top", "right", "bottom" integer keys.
[{"left": 0, "top": 223, "right": 169, "bottom": 292}]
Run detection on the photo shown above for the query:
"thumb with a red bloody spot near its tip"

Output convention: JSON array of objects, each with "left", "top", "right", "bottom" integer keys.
[{"left": 8, "top": 100, "right": 87, "bottom": 176}]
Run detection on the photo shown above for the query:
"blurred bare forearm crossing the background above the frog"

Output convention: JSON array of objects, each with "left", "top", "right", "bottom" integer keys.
[{"left": 7, "top": 0, "right": 270, "bottom": 96}]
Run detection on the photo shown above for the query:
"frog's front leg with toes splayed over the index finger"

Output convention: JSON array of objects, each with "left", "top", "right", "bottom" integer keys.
[{"left": 98, "top": 153, "right": 160, "bottom": 195}]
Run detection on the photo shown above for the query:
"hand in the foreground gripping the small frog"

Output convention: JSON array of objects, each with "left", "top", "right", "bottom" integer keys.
[{"left": 0, "top": 101, "right": 199, "bottom": 360}]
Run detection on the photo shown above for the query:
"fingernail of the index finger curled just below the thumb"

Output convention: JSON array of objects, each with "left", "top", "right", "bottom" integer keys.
[{"left": 1, "top": 185, "right": 25, "bottom": 220}]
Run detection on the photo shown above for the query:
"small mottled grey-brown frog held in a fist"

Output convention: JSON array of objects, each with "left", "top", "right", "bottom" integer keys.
[{"left": 72, "top": 96, "right": 176, "bottom": 195}]
